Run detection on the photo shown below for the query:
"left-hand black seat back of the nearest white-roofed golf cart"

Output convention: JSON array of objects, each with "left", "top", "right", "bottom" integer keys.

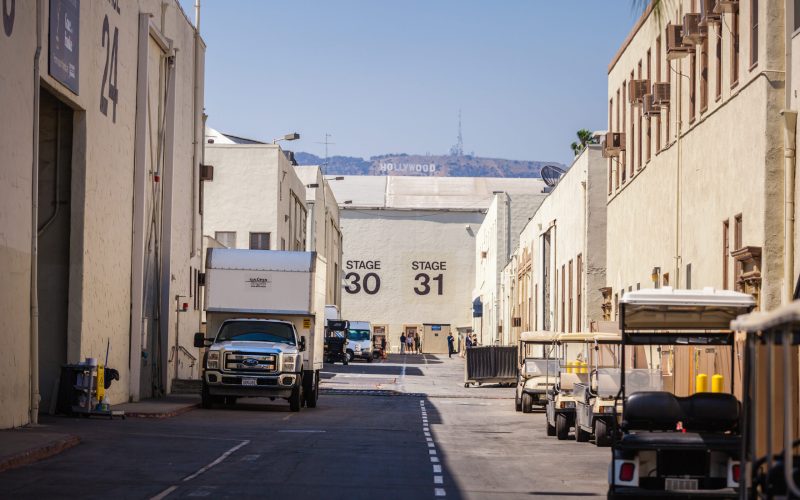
[{"left": 622, "top": 391, "right": 683, "bottom": 431}]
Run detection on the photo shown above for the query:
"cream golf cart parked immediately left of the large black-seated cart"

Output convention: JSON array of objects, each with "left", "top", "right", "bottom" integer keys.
[{"left": 575, "top": 333, "right": 621, "bottom": 446}]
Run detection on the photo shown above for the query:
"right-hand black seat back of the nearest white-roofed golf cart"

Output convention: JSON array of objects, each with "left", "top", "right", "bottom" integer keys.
[{"left": 678, "top": 392, "right": 741, "bottom": 432}]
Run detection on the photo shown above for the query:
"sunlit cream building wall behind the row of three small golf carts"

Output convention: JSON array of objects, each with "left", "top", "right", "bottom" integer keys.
[{"left": 503, "top": 145, "right": 606, "bottom": 339}]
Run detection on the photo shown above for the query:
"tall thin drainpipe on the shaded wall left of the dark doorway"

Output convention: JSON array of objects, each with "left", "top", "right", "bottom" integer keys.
[{"left": 30, "top": 0, "right": 43, "bottom": 424}]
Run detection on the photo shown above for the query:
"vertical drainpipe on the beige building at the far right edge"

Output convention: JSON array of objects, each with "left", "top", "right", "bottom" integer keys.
[{"left": 781, "top": 110, "right": 797, "bottom": 304}]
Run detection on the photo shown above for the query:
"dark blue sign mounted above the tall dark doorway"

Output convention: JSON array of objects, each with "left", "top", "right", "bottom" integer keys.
[{"left": 48, "top": 0, "right": 81, "bottom": 95}]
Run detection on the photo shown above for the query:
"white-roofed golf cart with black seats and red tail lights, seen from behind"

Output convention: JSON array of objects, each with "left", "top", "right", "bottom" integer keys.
[{"left": 608, "top": 287, "right": 755, "bottom": 499}]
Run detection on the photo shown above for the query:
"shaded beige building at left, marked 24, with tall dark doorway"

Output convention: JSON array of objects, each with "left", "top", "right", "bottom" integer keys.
[{"left": 0, "top": 0, "right": 205, "bottom": 428}]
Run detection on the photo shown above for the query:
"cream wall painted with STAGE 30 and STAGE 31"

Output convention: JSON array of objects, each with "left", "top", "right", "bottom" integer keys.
[{"left": 340, "top": 208, "right": 484, "bottom": 350}]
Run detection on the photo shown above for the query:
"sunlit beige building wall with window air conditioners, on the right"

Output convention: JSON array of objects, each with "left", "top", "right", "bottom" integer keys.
[{"left": 607, "top": 0, "right": 784, "bottom": 309}]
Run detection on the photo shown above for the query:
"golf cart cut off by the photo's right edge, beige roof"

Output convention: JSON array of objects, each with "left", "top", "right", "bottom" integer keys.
[{"left": 731, "top": 301, "right": 800, "bottom": 499}]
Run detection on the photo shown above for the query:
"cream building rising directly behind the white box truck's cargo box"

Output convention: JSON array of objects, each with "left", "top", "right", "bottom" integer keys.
[{"left": 203, "top": 144, "right": 307, "bottom": 251}]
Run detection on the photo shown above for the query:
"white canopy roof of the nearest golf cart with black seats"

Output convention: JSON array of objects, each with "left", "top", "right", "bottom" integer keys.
[{"left": 619, "top": 287, "right": 755, "bottom": 333}]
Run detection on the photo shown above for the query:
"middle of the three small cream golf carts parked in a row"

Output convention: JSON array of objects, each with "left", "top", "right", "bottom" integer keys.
[{"left": 545, "top": 333, "right": 592, "bottom": 440}]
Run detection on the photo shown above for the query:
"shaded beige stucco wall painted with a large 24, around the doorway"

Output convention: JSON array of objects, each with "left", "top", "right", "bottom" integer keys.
[{"left": 0, "top": 0, "right": 203, "bottom": 428}]
